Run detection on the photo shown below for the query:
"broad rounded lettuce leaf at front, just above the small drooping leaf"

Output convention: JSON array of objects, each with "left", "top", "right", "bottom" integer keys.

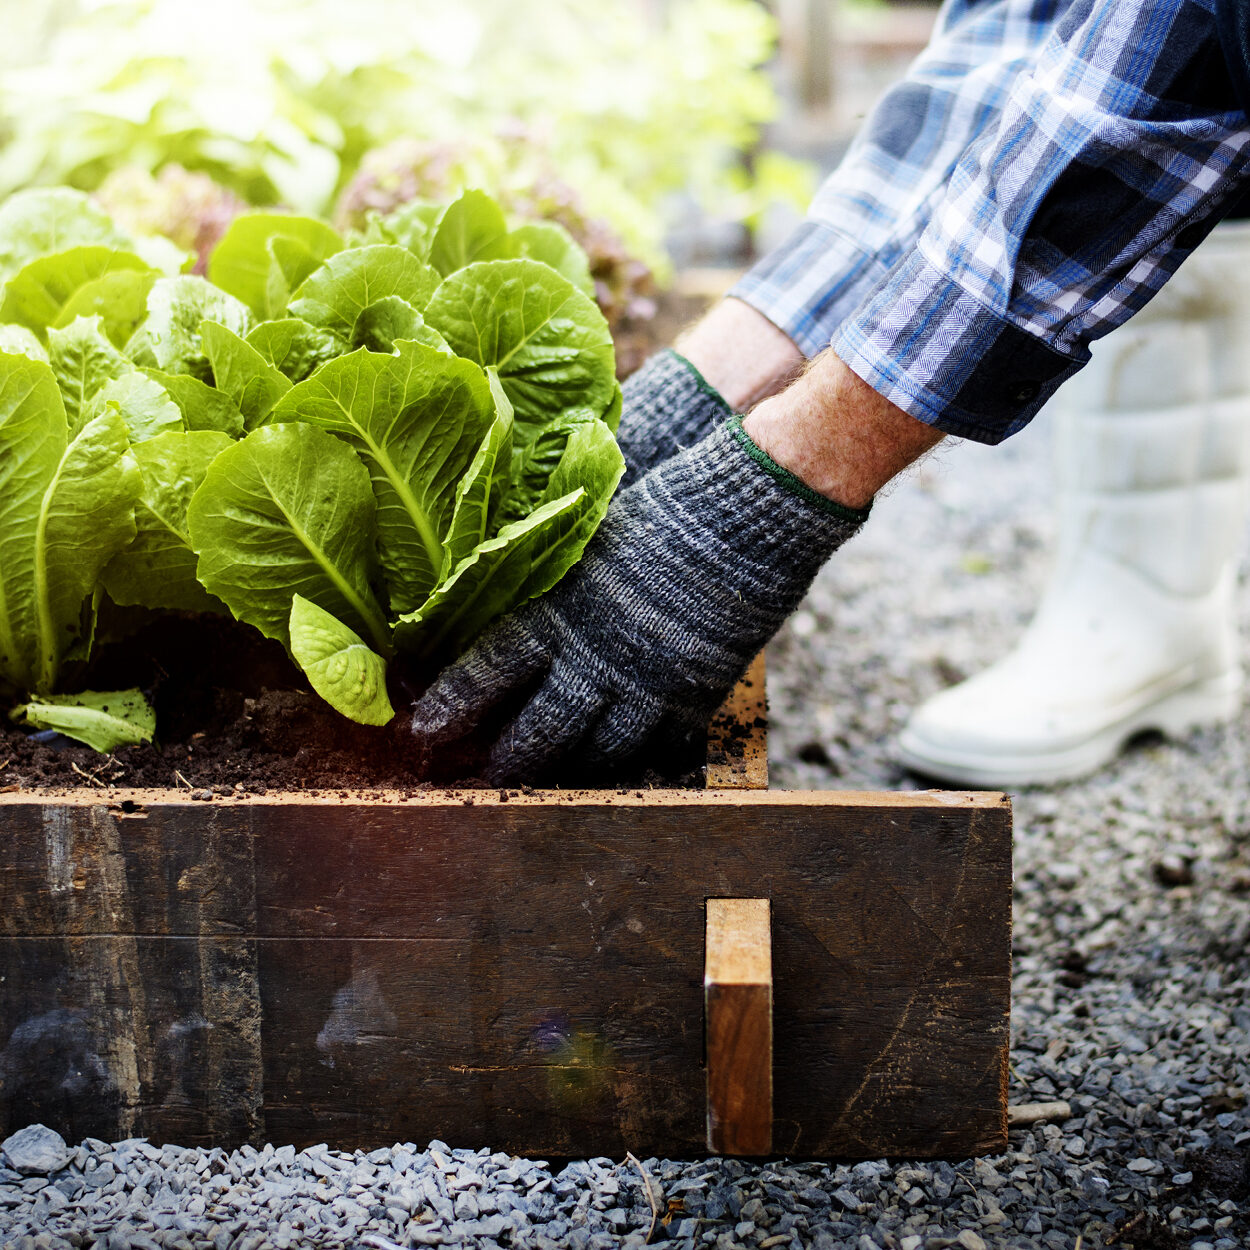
[{"left": 188, "top": 423, "right": 390, "bottom": 654}]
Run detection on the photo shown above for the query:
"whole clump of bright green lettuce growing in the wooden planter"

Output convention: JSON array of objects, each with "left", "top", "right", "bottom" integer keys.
[{"left": 0, "top": 189, "right": 624, "bottom": 750}]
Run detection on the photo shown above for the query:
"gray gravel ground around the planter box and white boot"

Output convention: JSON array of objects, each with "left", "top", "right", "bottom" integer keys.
[{"left": 0, "top": 430, "right": 1250, "bottom": 1250}]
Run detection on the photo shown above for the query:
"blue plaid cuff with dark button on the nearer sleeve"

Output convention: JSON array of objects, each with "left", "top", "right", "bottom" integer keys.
[{"left": 833, "top": 251, "right": 1089, "bottom": 444}]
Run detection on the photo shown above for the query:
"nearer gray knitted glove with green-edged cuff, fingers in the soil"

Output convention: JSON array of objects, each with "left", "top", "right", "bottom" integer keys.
[{"left": 413, "top": 418, "right": 868, "bottom": 784}]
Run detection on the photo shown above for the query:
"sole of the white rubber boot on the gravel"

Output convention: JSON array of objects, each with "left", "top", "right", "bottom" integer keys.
[{"left": 895, "top": 671, "right": 1241, "bottom": 789}]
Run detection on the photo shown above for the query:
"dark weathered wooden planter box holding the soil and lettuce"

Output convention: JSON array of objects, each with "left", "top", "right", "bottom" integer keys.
[{"left": 0, "top": 674, "right": 1011, "bottom": 1158}]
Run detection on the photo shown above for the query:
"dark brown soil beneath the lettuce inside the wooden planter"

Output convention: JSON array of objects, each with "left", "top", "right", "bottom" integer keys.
[{"left": 0, "top": 618, "right": 704, "bottom": 798}]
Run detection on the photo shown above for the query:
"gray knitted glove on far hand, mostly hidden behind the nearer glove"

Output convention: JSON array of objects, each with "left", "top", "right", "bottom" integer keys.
[{"left": 616, "top": 349, "right": 731, "bottom": 490}]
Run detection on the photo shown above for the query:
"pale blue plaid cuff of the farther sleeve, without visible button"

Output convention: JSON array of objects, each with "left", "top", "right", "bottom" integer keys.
[{"left": 728, "top": 218, "right": 886, "bottom": 360}]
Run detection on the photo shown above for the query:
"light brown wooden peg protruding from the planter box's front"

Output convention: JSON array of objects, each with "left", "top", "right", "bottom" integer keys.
[{"left": 704, "top": 899, "right": 773, "bottom": 1155}]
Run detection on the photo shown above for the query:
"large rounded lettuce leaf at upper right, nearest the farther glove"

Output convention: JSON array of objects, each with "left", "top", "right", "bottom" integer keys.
[{"left": 425, "top": 260, "right": 616, "bottom": 446}]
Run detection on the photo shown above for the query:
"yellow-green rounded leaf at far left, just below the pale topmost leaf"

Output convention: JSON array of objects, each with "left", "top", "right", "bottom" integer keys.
[{"left": 0, "top": 248, "right": 158, "bottom": 346}]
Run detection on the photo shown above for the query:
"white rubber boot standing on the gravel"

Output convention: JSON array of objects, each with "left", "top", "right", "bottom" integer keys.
[{"left": 898, "top": 223, "right": 1250, "bottom": 788}]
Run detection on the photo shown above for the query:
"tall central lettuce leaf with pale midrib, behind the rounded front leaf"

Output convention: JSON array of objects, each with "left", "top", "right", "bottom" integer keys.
[{"left": 270, "top": 343, "right": 495, "bottom": 611}]
